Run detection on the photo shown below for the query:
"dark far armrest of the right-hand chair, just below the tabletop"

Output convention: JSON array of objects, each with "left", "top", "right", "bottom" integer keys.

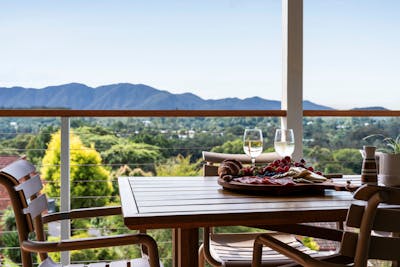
[{"left": 254, "top": 224, "right": 343, "bottom": 242}]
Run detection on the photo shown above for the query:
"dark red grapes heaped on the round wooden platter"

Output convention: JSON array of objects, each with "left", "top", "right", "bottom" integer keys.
[{"left": 241, "top": 157, "right": 322, "bottom": 176}]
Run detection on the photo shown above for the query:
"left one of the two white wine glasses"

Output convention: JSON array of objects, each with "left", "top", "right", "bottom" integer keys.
[{"left": 243, "top": 129, "right": 263, "bottom": 167}]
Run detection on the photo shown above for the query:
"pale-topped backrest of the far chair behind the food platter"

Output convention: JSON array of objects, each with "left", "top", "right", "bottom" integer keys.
[{"left": 203, "top": 151, "right": 281, "bottom": 176}]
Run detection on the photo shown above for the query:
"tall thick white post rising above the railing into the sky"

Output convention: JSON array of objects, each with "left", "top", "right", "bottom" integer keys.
[{"left": 281, "top": 0, "right": 303, "bottom": 160}]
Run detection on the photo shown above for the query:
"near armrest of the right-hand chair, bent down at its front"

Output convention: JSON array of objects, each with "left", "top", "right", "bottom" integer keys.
[{"left": 252, "top": 234, "right": 343, "bottom": 267}]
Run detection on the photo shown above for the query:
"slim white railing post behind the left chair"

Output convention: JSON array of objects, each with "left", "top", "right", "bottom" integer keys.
[{"left": 60, "top": 117, "right": 71, "bottom": 266}]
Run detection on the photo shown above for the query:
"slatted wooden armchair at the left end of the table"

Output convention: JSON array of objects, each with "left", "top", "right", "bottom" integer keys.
[{"left": 0, "top": 159, "right": 160, "bottom": 267}]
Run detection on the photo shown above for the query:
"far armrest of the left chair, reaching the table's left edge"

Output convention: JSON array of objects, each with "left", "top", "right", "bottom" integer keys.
[{"left": 43, "top": 206, "right": 122, "bottom": 223}]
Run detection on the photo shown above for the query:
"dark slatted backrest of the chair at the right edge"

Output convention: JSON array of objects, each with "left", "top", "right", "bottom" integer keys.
[{"left": 340, "top": 185, "right": 400, "bottom": 266}]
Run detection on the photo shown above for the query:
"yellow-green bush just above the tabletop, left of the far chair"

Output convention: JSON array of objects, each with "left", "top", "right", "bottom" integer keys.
[{"left": 156, "top": 155, "right": 200, "bottom": 176}]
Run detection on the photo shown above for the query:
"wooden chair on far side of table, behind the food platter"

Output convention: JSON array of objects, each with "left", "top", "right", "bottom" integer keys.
[{"left": 199, "top": 151, "right": 331, "bottom": 267}]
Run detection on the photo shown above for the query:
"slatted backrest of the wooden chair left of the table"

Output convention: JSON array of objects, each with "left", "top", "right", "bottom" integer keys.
[{"left": 0, "top": 159, "right": 48, "bottom": 266}]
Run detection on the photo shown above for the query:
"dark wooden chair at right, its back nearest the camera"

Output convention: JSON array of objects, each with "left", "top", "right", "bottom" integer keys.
[{"left": 252, "top": 185, "right": 400, "bottom": 267}]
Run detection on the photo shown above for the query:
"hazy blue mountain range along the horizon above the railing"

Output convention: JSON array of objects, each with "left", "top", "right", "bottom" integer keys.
[{"left": 0, "top": 83, "right": 332, "bottom": 110}]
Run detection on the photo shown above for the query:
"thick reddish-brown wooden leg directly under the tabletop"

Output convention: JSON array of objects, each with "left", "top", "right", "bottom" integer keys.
[{"left": 173, "top": 228, "right": 199, "bottom": 267}]
